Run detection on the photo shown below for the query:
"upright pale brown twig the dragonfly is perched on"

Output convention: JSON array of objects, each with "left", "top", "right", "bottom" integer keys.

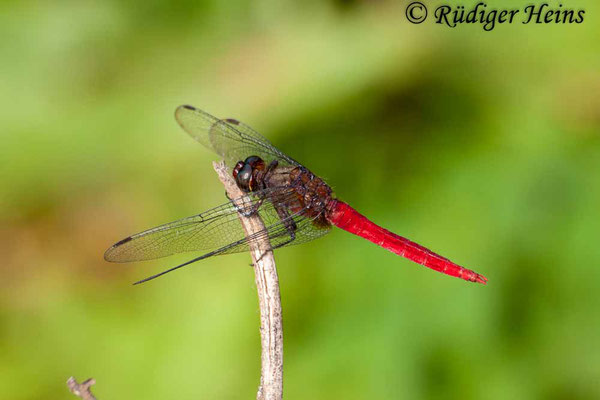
[{"left": 213, "top": 161, "right": 283, "bottom": 400}]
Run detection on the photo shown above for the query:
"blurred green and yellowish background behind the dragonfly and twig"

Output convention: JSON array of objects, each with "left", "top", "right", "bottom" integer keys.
[{"left": 0, "top": 0, "right": 600, "bottom": 400}]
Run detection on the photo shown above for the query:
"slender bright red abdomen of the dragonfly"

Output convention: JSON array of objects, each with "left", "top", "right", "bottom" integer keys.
[{"left": 327, "top": 200, "right": 487, "bottom": 285}]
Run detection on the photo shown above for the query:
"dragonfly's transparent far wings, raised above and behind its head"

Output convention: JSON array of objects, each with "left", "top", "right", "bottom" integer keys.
[{"left": 175, "top": 105, "right": 300, "bottom": 168}]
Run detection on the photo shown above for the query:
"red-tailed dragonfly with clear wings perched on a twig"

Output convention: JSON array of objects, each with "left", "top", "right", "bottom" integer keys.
[{"left": 104, "top": 105, "right": 487, "bottom": 285}]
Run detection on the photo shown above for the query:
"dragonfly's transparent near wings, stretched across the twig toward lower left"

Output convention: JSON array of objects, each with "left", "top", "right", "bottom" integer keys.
[{"left": 104, "top": 187, "right": 329, "bottom": 262}]
